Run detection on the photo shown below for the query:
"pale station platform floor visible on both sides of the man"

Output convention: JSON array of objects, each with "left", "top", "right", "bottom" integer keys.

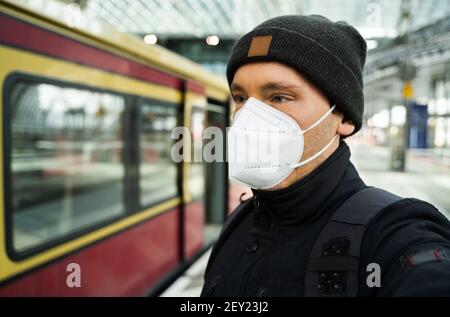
[{"left": 161, "top": 141, "right": 450, "bottom": 297}]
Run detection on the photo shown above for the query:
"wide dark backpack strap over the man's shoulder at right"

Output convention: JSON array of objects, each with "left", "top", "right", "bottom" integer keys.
[{"left": 305, "top": 187, "right": 401, "bottom": 297}]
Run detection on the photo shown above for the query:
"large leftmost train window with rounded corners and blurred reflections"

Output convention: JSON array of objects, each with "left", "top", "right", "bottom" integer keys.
[{"left": 6, "top": 81, "right": 125, "bottom": 252}]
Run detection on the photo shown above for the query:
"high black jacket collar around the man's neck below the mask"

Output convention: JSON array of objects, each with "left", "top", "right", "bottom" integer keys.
[{"left": 252, "top": 141, "right": 364, "bottom": 231}]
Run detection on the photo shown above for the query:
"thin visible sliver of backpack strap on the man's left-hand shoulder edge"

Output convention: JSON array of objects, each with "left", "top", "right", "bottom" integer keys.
[{"left": 205, "top": 197, "right": 254, "bottom": 276}]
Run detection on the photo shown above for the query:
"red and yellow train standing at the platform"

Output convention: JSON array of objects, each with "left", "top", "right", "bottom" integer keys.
[{"left": 0, "top": 1, "right": 246, "bottom": 296}]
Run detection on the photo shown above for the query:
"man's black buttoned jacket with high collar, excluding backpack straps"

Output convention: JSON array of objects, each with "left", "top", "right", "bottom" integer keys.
[{"left": 202, "top": 142, "right": 450, "bottom": 296}]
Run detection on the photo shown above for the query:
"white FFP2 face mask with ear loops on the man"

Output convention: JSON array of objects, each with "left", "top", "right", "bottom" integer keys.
[{"left": 228, "top": 97, "right": 338, "bottom": 189}]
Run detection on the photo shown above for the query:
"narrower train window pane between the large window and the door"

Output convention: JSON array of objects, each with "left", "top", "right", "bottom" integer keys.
[{"left": 139, "top": 100, "right": 177, "bottom": 207}]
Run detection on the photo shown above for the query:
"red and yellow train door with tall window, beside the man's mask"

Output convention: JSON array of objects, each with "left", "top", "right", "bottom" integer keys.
[{"left": 181, "top": 81, "right": 228, "bottom": 259}]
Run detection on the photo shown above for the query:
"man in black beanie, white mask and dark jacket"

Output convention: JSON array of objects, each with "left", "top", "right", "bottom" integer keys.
[{"left": 202, "top": 15, "right": 450, "bottom": 297}]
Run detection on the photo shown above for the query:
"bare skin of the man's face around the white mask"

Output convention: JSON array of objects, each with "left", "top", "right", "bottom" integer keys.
[{"left": 231, "top": 62, "right": 354, "bottom": 190}]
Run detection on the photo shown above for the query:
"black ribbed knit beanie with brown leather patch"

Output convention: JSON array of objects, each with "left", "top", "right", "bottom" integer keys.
[{"left": 227, "top": 15, "right": 367, "bottom": 134}]
